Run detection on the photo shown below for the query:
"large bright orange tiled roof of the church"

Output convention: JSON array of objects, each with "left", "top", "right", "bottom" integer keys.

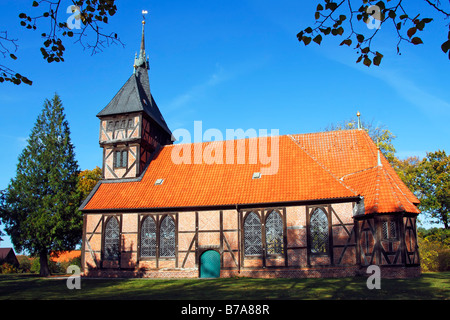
[{"left": 83, "top": 130, "right": 419, "bottom": 213}]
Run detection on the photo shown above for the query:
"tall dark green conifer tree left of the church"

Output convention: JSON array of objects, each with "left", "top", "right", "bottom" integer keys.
[{"left": 0, "top": 94, "right": 82, "bottom": 276}]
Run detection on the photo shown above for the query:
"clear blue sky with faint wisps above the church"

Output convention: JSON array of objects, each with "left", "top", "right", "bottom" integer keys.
[{"left": 0, "top": 0, "right": 450, "bottom": 250}]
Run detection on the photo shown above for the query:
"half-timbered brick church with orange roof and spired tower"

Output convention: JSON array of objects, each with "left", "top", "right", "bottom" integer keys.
[{"left": 80, "top": 21, "right": 421, "bottom": 278}]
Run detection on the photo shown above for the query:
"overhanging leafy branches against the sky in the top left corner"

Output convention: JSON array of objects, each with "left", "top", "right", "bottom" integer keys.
[{"left": 0, "top": 0, "right": 123, "bottom": 85}]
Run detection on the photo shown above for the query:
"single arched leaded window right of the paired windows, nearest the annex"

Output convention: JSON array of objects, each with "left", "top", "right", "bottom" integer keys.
[{"left": 310, "top": 208, "right": 329, "bottom": 254}]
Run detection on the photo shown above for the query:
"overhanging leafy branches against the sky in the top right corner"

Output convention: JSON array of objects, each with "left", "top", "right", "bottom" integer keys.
[{"left": 297, "top": 0, "right": 450, "bottom": 67}]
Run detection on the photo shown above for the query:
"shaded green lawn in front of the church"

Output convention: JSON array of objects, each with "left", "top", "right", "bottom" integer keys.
[{"left": 0, "top": 272, "right": 450, "bottom": 301}]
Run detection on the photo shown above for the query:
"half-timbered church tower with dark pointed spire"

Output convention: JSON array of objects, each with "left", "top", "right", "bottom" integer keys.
[{"left": 97, "top": 15, "right": 172, "bottom": 179}]
